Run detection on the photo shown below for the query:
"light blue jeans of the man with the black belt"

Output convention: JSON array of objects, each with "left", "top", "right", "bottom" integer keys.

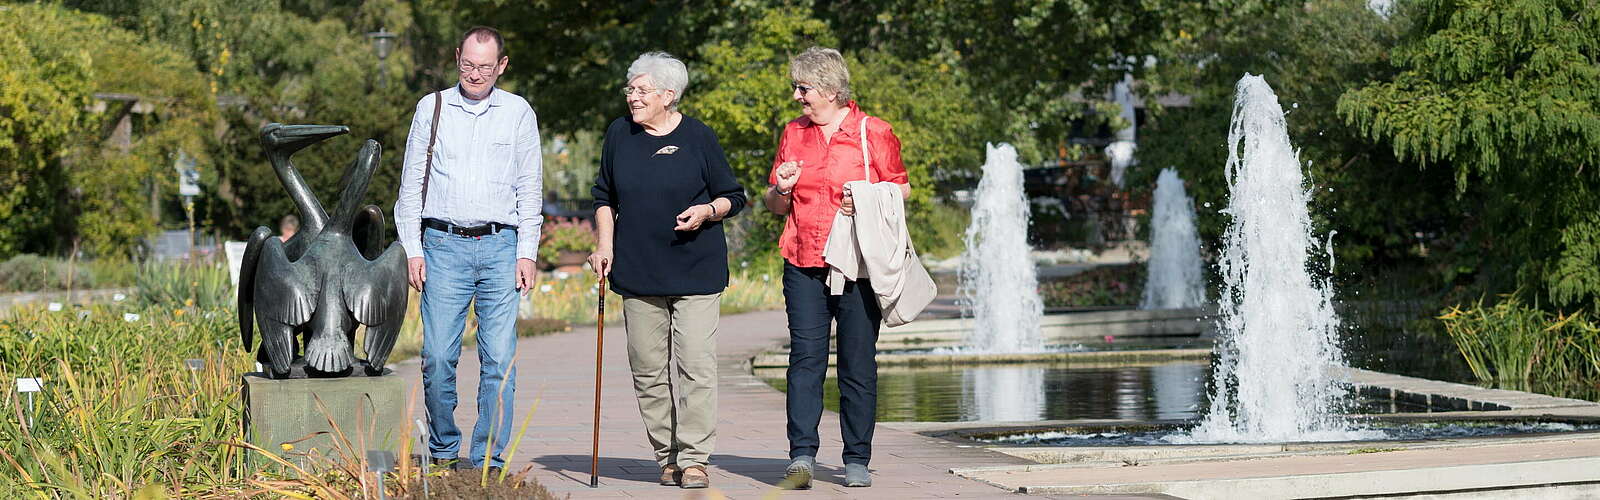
[{"left": 422, "top": 229, "right": 518, "bottom": 466}]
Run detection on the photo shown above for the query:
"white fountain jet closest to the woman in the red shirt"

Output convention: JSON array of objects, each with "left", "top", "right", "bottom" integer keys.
[{"left": 960, "top": 144, "right": 1045, "bottom": 353}]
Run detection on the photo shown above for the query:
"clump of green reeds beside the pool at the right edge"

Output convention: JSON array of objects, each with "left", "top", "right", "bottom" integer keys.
[{"left": 1438, "top": 296, "right": 1600, "bottom": 397}]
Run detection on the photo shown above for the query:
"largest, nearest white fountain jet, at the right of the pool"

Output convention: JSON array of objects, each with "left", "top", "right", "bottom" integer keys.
[{"left": 1189, "top": 74, "right": 1370, "bottom": 442}]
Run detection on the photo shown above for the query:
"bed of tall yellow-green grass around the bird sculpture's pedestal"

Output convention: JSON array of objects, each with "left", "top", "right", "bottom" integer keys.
[{"left": 0, "top": 282, "right": 554, "bottom": 498}]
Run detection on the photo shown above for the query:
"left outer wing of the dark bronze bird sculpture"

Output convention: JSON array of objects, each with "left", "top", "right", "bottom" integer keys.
[{"left": 253, "top": 237, "right": 318, "bottom": 372}]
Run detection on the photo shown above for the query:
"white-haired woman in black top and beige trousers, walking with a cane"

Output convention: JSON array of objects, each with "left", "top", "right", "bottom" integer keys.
[{"left": 589, "top": 53, "right": 746, "bottom": 489}]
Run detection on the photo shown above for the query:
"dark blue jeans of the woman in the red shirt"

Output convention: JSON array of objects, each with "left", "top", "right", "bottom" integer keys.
[{"left": 784, "top": 263, "right": 883, "bottom": 465}]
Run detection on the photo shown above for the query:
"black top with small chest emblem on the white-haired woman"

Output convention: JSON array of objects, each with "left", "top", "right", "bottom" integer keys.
[{"left": 592, "top": 115, "right": 746, "bottom": 296}]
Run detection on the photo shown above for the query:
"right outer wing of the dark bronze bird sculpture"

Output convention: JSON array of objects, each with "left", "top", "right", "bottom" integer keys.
[{"left": 344, "top": 242, "right": 411, "bottom": 372}]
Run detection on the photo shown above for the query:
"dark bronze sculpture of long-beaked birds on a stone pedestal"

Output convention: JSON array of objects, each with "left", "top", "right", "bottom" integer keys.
[{"left": 238, "top": 123, "right": 410, "bottom": 378}]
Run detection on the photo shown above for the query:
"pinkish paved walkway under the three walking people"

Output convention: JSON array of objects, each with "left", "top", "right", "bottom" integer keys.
[{"left": 395, "top": 311, "right": 1147, "bottom": 498}]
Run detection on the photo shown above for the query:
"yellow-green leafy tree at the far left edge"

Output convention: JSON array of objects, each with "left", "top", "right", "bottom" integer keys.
[{"left": 0, "top": 5, "right": 216, "bottom": 255}]
